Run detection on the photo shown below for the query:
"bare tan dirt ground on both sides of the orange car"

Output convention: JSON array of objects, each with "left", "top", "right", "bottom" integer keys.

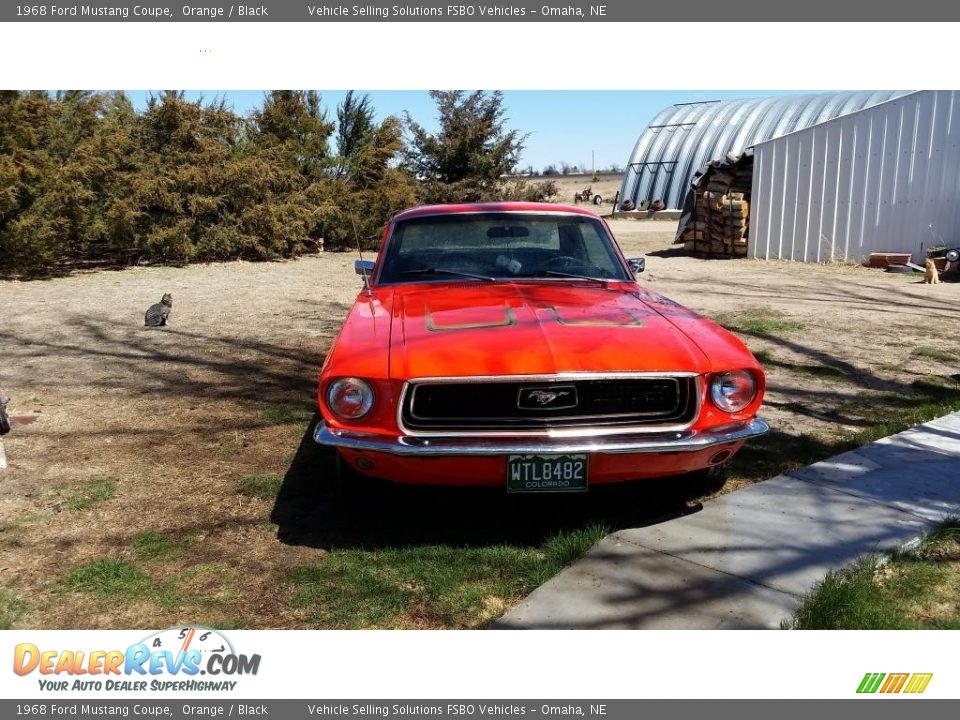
[{"left": 0, "top": 220, "right": 960, "bottom": 628}]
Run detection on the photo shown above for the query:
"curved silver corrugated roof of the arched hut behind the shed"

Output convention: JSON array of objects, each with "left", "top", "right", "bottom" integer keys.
[{"left": 620, "top": 90, "right": 907, "bottom": 208}]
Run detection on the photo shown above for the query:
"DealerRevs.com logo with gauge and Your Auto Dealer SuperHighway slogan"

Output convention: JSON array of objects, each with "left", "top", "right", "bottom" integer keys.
[{"left": 13, "top": 625, "right": 260, "bottom": 692}]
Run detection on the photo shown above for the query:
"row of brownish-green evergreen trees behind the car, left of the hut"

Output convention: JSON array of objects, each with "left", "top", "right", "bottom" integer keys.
[{"left": 0, "top": 90, "right": 506, "bottom": 276}]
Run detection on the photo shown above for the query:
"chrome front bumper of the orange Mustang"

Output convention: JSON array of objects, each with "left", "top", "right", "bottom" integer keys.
[{"left": 313, "top": 417, "right": 770, "bottom": 457}]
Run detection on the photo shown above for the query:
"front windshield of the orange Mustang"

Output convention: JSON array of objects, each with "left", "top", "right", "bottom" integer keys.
[{"left": 380, "top": 213, "right": 631, "bottom": 283}]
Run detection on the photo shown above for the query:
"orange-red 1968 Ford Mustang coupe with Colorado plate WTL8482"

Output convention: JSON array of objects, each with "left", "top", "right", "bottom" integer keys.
[{"left": 314, "top": 203, "right": 767, "bottom": 492}]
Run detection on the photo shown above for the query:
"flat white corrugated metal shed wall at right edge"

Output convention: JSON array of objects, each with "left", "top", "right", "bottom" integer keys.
[{"left": 748, "top": 90, "right": 960, "bottom": 262}]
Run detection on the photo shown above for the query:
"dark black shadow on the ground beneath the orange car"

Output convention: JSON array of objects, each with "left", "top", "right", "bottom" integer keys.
[{"left": 270, "top": 415, "right": 700, "bottom": 550}]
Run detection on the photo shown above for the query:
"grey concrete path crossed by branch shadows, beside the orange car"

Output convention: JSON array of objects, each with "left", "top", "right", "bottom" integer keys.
[{"left": 495, "top": 412, "right": 960, "bottom": 629}]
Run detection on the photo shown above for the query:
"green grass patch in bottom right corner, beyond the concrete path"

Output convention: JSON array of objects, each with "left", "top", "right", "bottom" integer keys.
[{"left": 788, "top": 519, "right": 960, "bottom": 630}]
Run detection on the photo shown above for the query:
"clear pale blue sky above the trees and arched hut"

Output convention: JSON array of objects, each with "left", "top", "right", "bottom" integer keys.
[{"left": 128, "top": 90, "right": 800, "bottom": 170}]
